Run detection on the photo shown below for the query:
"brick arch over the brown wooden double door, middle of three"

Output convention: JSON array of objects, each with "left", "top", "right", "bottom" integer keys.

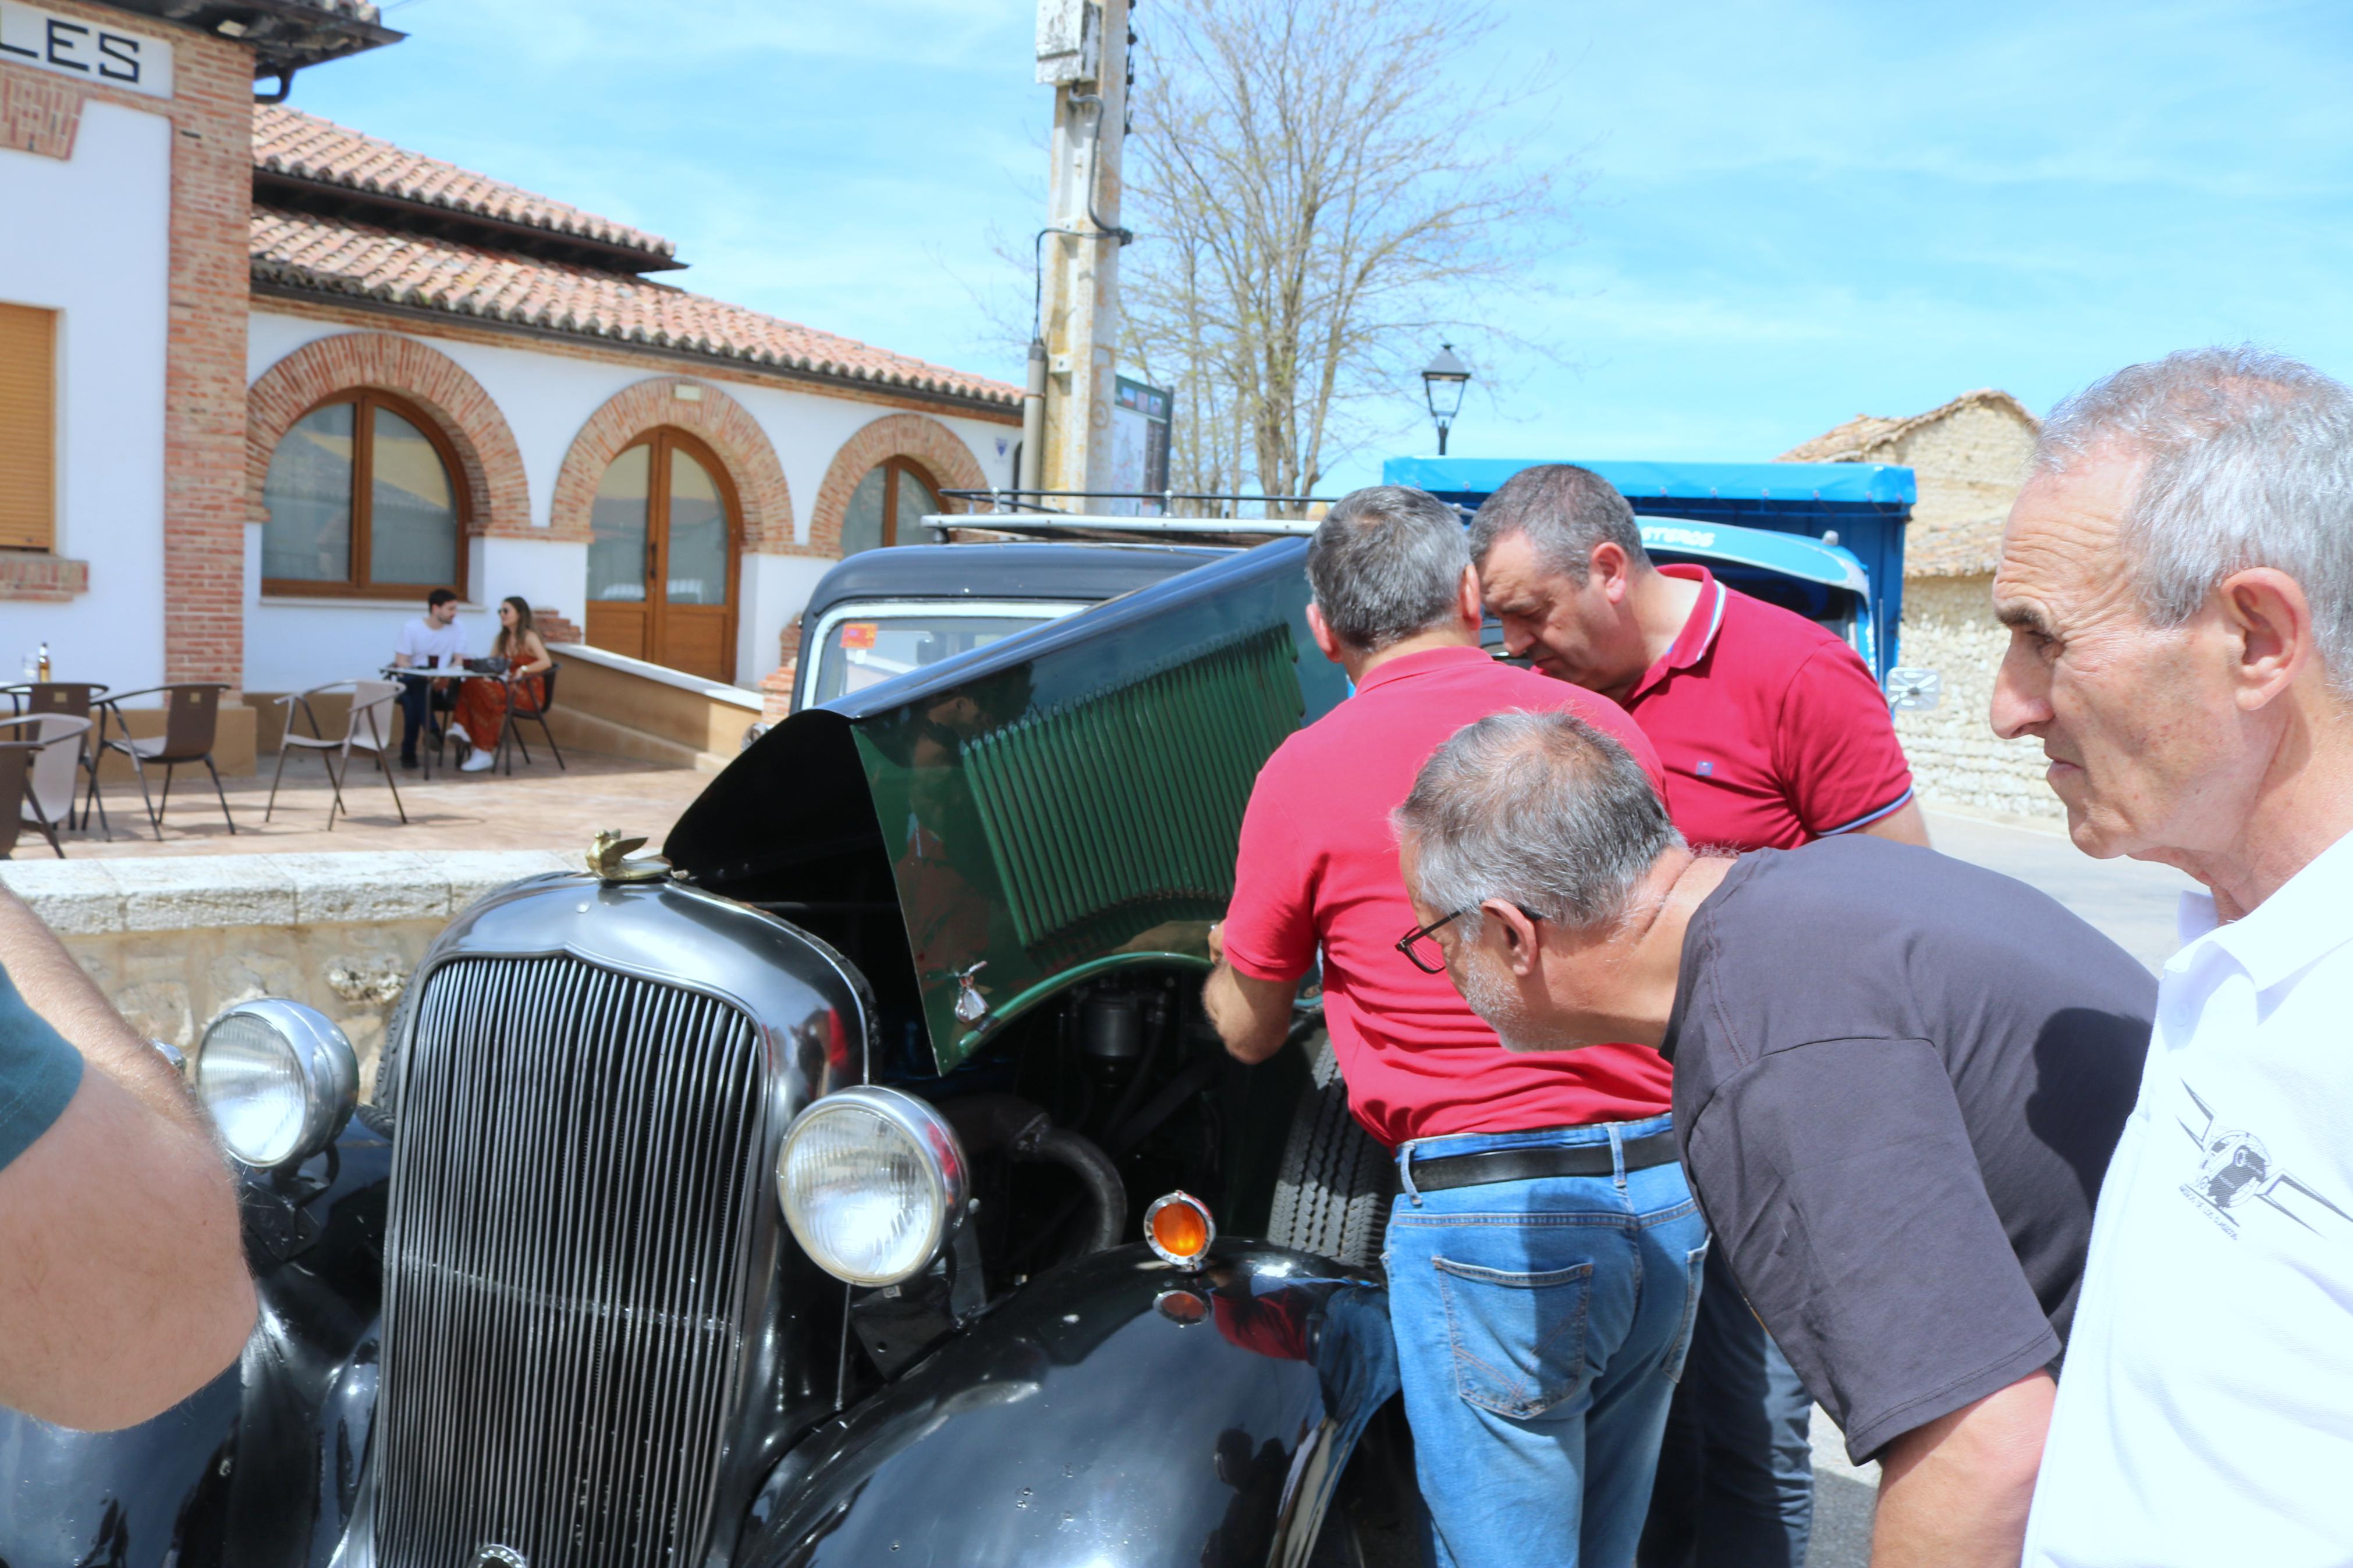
[{"left": 551, "top": 376, "right": 793, "bottom": 555}]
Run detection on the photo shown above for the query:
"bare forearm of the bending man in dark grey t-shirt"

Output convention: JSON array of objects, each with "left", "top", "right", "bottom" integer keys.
[{"left": 1871, "top": 1373, "right": 2057, "bottom": 1568}]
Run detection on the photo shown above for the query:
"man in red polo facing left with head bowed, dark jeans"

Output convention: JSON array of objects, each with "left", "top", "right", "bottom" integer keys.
[{"left": 1471, "top": 463, "right": 1927, "bottom": 1568}]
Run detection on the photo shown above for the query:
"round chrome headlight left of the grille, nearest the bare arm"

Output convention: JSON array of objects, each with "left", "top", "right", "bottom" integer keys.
[{"left": 196, "top": 997, "right": 360, "bottom": 1168}]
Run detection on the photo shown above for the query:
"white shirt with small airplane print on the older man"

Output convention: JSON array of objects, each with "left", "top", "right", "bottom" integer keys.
[{"left": 2026, "top": 834, "right": 2353, "bottom": 1568}]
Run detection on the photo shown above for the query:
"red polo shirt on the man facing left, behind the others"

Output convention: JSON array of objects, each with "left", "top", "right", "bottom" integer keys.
[{"left": 1626, "top": 567, "right": 1911, "bottom": 849}]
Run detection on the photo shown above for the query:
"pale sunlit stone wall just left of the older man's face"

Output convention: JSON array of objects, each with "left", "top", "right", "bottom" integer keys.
[{"left": 1897, "top": 576, "right": 2064, "bottom": 816}]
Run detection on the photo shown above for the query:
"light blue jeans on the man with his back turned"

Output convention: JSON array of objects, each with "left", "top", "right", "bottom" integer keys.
[{"left": 1383, "top": 1117, "right": 1708, "bottom": 1568}]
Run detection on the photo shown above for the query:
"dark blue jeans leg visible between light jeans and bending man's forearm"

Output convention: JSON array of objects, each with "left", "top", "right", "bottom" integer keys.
[{"left": 1640, "top": 1256, "right": 1814, "bottom": 1568}]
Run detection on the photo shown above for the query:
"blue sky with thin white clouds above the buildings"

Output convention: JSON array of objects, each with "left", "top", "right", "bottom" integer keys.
[{"left": 294, "top": 0, "right": 2353, "bottom": 486}]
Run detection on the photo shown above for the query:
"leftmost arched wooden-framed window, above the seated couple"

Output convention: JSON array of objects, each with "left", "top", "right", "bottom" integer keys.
[{"left": 261, "top": 390, "right": 466, "bottom": 597}]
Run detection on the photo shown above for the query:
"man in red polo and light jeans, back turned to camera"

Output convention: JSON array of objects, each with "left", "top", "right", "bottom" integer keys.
[{"left": 1205, "top": 486, "right": 1706, "bottom": 1568}]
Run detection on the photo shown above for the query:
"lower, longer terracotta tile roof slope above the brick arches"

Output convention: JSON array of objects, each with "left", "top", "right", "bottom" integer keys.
[{"left": 252, "top": 210, "right": 1021, "bottom": 407}]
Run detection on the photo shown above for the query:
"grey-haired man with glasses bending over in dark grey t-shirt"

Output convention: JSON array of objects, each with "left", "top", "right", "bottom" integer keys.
[{"left": 1398, "top": 714, "right": 2155, "bottom": 1568}]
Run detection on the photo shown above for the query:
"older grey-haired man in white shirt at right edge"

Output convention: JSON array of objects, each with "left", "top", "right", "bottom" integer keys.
[{"left": 1993, "top": 348, "right": 2353, "bottom": 1568}]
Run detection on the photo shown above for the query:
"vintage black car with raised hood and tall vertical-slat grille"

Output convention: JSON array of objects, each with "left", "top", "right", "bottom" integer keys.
[{"left": 0, "top": 538, "right": 1419, "bottom": 1568}]
